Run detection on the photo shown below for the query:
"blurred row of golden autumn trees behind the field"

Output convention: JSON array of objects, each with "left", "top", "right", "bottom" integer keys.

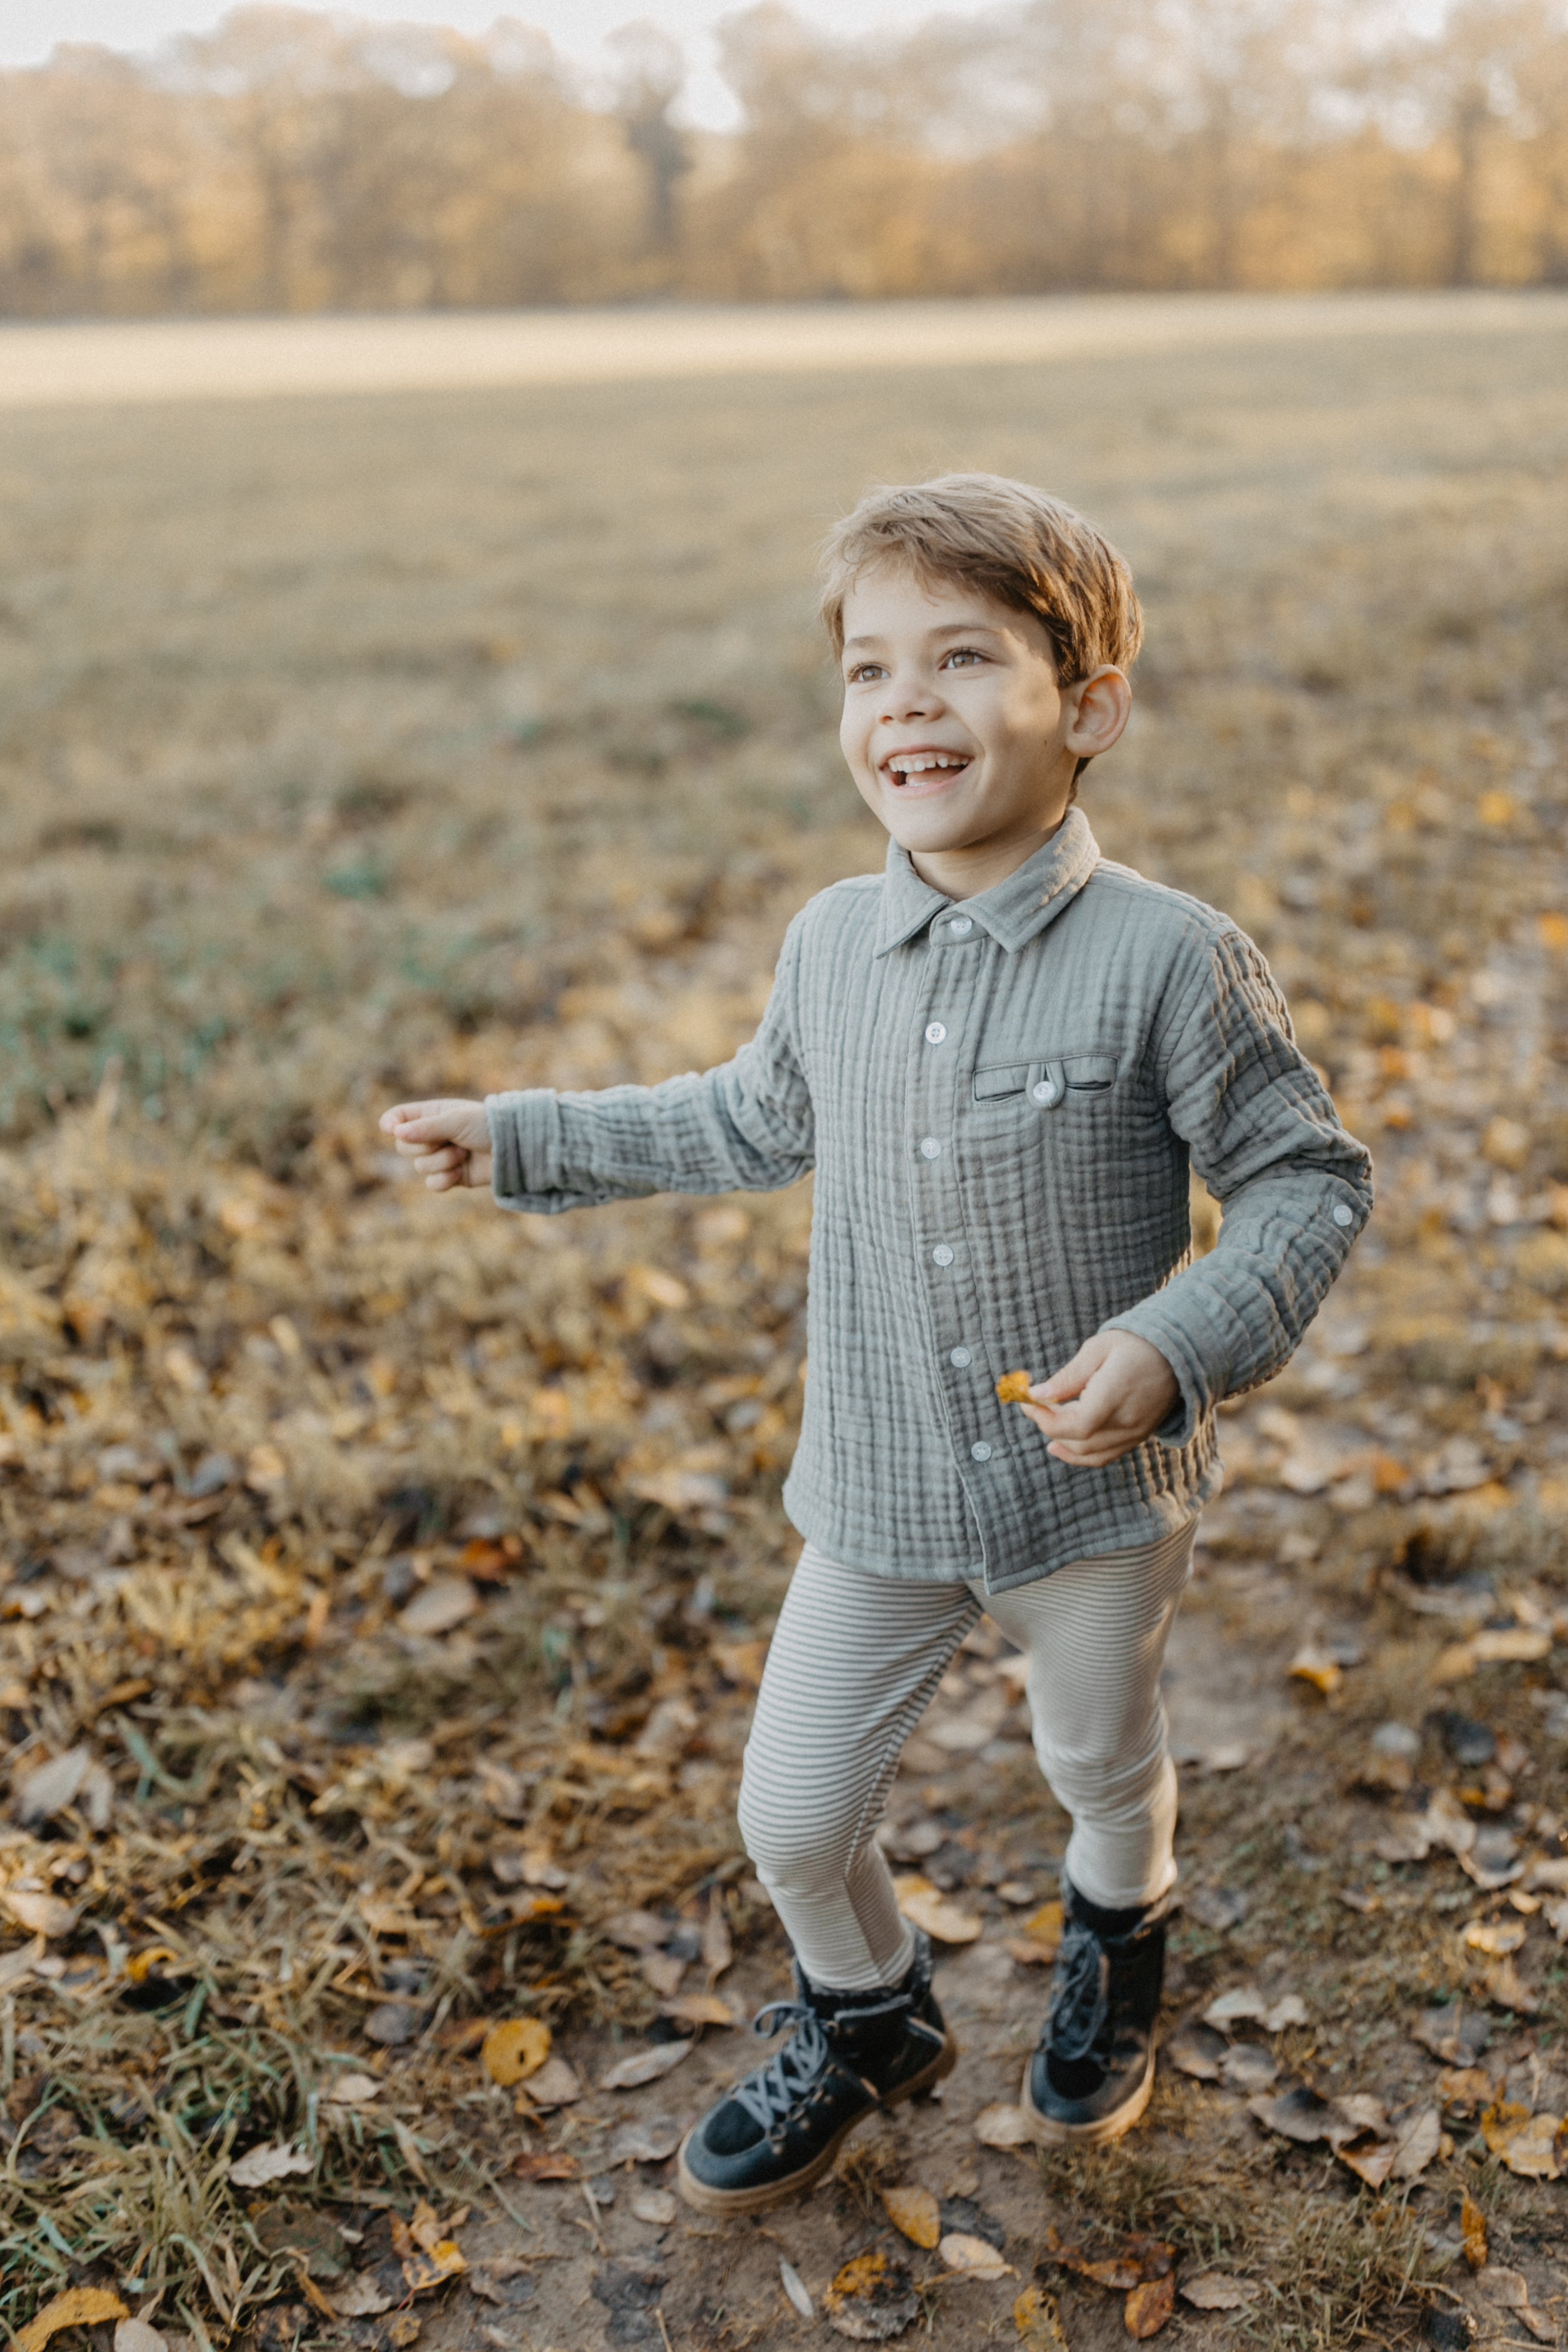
[{"left": 0, "top": 0, "right": 1568, "bottom": 318}]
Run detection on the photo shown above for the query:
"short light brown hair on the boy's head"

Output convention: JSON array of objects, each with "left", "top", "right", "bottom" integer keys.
[{"left": 820, "top": 473, "right": 1142, "bottom": 687}]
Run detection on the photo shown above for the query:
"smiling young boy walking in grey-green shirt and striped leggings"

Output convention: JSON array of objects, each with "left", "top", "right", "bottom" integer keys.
[{"left": 381, "top": 475, "right": 1370, "bottom": 2213}]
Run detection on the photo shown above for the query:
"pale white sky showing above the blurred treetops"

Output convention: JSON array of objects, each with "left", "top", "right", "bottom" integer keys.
[{"left": 0, "top": 0, "right": 992, "bottom": 129}]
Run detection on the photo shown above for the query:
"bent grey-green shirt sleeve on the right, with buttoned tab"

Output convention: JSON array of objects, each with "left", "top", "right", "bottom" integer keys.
[{"left": 1105, "top": 927, "right": 1373, "bottom": 1446}]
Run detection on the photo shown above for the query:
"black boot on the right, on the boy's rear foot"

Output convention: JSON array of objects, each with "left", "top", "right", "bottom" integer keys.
[{"left": 1022, "top": 1879, "right": 1171, "bottom": 2147}]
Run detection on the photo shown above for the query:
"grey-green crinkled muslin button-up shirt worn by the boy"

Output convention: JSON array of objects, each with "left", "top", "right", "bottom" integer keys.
[{"left": 487, "top": 809, "right": 1373, "bottom": 1592}]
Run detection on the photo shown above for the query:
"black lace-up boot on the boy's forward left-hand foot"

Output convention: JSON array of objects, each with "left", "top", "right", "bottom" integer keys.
[{"left": 680, "top": 1933, "right": 959, "bottom": 2213}]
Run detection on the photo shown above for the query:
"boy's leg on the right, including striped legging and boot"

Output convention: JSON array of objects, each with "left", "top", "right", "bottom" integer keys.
[{"left": 989, "top": 1526, "right": 1194, "bottom": 2145}]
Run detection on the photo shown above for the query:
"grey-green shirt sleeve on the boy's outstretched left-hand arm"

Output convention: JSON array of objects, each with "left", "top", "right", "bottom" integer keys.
[{"left": 484, "top": 915, "right": 815, "bottom": 1216}]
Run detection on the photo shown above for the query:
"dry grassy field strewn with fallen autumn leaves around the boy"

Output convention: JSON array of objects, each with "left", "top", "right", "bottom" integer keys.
[{"left": 0, "top": 301, "right": 1568, "bottom": 2352}]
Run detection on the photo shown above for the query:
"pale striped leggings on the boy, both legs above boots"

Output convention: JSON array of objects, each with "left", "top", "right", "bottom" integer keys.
[{"left": 741, "top": 1526, "right": 1194, "bottom": 1992}]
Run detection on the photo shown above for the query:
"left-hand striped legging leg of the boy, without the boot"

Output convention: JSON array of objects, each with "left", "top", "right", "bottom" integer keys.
[{"left": 741, "top": 1545, "right": 980, "bottom": 1992}]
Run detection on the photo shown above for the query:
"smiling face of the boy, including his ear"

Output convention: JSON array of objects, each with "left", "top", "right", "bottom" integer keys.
[{"left": 839, "top": 564, "right": 1128, "bottom": 889}]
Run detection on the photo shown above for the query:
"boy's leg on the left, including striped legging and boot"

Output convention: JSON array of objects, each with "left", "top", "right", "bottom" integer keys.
[{"left": 680, "top": 1548, "right": 980, "bottom": 2213}]
